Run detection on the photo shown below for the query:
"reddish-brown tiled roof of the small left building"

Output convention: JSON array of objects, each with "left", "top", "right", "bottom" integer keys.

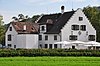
[{"left": 11, "top": 22, "right": 39, "bottom": 34}]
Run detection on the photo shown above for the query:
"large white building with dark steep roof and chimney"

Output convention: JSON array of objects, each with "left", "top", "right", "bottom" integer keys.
[{"left": 37, "top": 7, "right": 96, "bottom": 49}]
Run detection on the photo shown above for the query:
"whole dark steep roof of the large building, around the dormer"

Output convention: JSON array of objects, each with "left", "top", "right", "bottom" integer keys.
[{"left": 38, "top": 11, "right": 75, "bottom": 34}]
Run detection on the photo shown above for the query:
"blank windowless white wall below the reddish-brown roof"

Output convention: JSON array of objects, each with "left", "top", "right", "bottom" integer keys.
[{"left": 16, "top": 34, "right": 38, "bottom": 49}]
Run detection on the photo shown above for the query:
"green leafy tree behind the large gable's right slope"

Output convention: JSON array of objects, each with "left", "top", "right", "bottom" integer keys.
[{"left": 83, "top": 6, "right": 100, "bottom": 42}]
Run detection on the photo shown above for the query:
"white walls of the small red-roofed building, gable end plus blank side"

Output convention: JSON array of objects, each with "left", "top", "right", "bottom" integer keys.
[{"left": 6, "top": 24, "right": 38, "bottom": 49}]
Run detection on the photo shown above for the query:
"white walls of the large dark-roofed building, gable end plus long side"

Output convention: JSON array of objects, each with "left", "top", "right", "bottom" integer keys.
[{"left": 39, "top": 9, "right": 96, "bottom": 49}]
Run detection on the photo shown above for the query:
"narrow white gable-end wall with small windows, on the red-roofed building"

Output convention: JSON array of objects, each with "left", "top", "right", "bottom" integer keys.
[{"left": 5, "top": 24, "right": 17, "bottom": 48}]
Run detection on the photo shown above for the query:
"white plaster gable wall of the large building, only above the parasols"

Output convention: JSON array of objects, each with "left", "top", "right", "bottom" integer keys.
[{"left": 61, "top": 9, "right": 96, "bottom": 41}]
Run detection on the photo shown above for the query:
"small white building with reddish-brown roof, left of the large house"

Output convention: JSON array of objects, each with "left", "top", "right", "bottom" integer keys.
[{"left": 6, "top": 22, "right": 38, "bottom": 49}]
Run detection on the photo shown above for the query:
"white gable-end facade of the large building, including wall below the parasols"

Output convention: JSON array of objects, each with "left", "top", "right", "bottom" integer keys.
[{"left": 61, "top": 9, "right": 96, "bottom": 49}]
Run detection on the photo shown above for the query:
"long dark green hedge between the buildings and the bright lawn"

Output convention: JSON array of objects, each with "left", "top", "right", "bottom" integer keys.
[{"left": 0, "top": 49, "right": 100, "bottom": 57}]
